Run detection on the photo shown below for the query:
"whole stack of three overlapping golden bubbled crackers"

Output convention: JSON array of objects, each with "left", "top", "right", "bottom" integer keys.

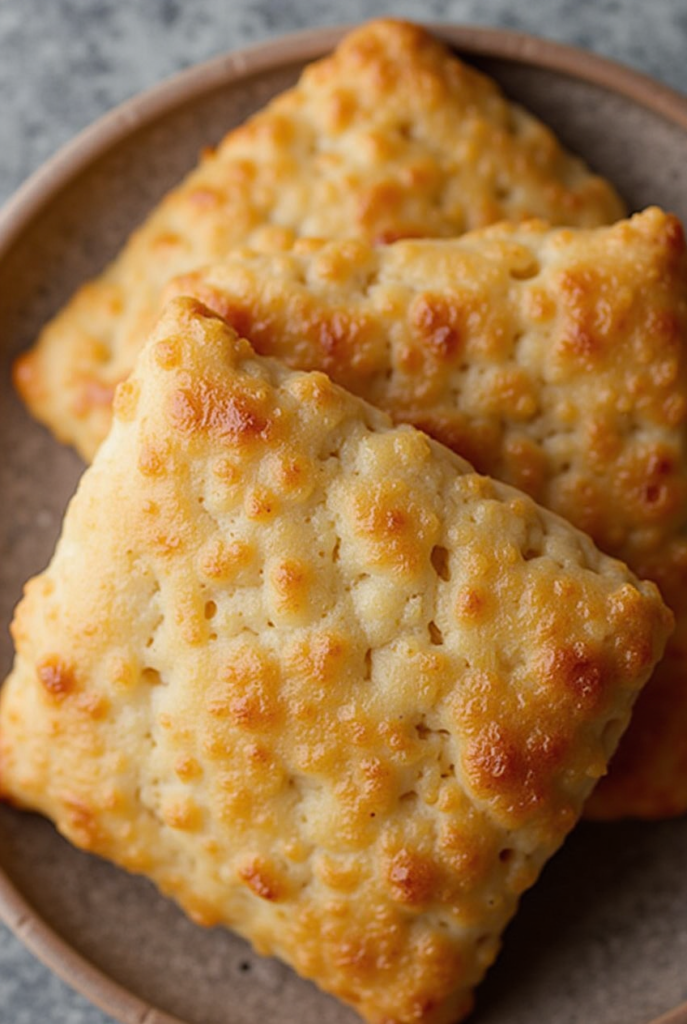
[{"left": 0, "top": 20, "right": 687, "bottom": 1024}]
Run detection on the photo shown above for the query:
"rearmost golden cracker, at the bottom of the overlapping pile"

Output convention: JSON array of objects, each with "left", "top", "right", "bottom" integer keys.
[{"left": 16, "top": 20, "right": 622, "bottom": 458}]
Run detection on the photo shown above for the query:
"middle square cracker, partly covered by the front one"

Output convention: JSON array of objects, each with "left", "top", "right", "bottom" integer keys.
[{"left": 167, "top": 208, "right": 687, "bottom": 818}]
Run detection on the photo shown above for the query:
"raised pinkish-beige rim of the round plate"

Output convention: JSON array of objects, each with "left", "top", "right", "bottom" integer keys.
[{"left": 0, "top": 24, "right": 687, "bottom": 1024}]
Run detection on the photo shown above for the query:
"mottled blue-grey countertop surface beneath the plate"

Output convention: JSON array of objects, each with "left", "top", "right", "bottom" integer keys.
[{"left": 0, "top": 0, "right": 687, "bottom": 1024}]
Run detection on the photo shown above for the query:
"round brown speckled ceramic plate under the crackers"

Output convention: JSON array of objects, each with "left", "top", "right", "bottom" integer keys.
[{"left": 0, "top": 27, "right": 687, "bottom": 1024}]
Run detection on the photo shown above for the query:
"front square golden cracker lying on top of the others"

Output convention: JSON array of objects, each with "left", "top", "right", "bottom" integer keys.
[{"left": 0, "top": 299, "right": 670, "bottom": 1024}]
